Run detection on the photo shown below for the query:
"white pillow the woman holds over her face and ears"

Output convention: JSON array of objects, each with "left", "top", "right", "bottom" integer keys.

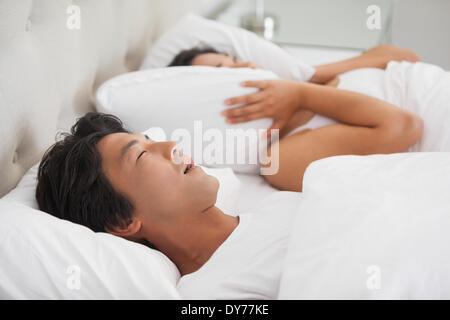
[{"left": 97, "top": 66, "right": 278, "bottom": 174}]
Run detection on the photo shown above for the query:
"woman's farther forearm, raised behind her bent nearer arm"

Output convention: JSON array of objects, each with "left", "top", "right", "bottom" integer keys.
[{"left": 309, "top": 45, "right": 421, "bottom": 84}]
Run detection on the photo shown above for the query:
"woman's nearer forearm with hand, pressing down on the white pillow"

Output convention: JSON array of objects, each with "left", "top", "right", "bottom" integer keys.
[{"left": 222, "top": 80, "right": 419, "bottom": 139}]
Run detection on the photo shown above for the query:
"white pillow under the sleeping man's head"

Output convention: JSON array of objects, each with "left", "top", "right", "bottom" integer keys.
[{"left": 0, "top": 154, "right": 240, "bottom": 299}]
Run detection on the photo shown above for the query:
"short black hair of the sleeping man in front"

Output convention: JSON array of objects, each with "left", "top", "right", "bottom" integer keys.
[{"left": 36, "top": 112, "right": 133, "bottom": 232}]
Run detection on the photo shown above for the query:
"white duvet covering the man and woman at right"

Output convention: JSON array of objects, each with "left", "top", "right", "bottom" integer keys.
[{"left": 279, "top": 62, "right": 450, "bottom": 299}]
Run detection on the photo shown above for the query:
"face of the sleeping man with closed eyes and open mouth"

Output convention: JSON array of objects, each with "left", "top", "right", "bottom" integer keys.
[{"left": 97, "top": 133, "right": 219, "bottom": 227}]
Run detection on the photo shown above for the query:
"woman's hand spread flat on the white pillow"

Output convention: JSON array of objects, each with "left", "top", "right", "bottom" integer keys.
[{"left": 222, "top": 79, "right": 301, "bottom": 135}]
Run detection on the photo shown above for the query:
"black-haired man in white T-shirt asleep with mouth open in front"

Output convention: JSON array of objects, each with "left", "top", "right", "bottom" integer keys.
[{"left": 36, "top": 113, "right": 296, "bottom": 299}]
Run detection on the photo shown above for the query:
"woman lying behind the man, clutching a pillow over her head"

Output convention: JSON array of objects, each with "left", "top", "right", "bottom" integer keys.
[{"left": 170, "top": 45, "right": 424, "bottom": 191}]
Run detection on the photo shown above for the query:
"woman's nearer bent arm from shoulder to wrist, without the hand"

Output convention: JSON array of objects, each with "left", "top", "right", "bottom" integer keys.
[{"left": 265, "top": 84, "right": 423, "bottom": 191}]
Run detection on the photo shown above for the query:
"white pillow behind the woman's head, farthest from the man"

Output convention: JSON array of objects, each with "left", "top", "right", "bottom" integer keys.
[{"left": 141, "top": 13, "right": 315, "bottom": 81}]
